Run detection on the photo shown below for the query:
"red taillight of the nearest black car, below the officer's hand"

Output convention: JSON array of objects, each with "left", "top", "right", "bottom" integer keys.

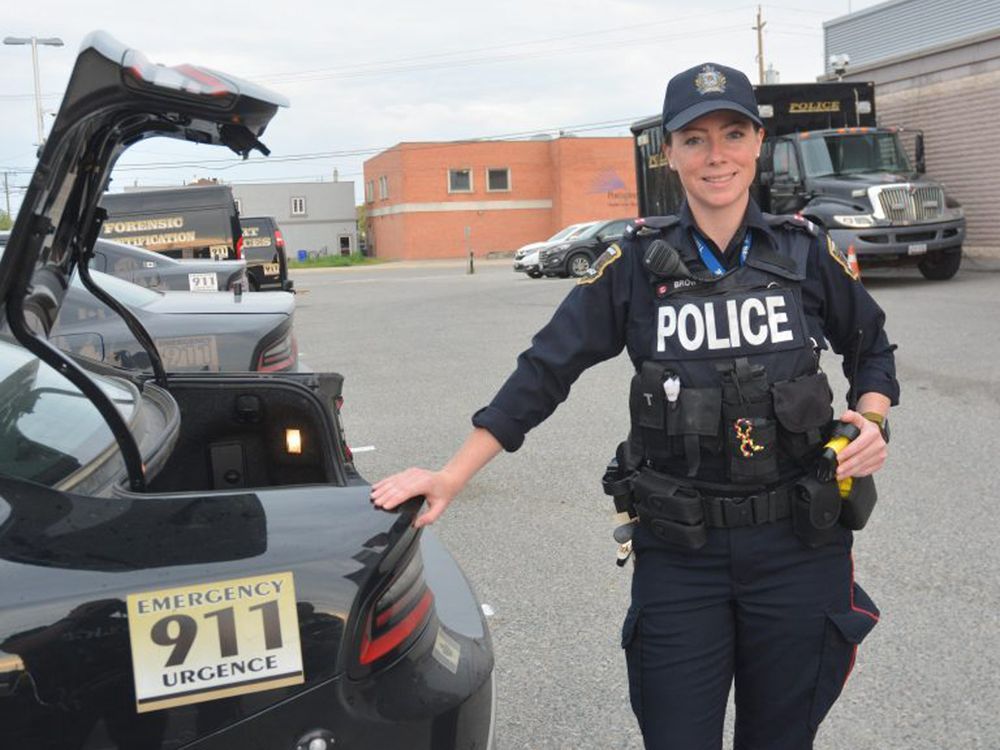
[{"left": 358, "top": 551, "right": 434, "bottom": 665}]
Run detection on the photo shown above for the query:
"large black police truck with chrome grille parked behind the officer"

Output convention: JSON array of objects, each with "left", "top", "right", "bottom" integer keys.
[{"left": 632, "top": 82, "right": 965, "bottom": 280}]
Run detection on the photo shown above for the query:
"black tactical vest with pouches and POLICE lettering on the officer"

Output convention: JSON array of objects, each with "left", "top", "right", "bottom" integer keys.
[{"left": 629, "top": 219, "right": 833, "bottom": 490}]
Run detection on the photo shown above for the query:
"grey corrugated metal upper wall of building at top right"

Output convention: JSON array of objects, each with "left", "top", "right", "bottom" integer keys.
[{"left": 823, "top": 0, "right": 1000, "bottom": 73}]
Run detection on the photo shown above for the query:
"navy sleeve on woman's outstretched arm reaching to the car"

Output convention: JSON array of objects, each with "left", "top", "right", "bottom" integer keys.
[{"left": 472, "top": 241, "right": 632, "bottom": 451}]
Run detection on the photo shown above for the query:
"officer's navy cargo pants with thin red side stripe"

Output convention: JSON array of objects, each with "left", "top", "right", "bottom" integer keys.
[{"left": 622, "top": 520, "right": 878, "bottom": 750}]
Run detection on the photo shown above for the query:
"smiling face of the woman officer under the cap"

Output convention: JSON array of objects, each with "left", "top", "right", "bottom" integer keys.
[{"left": 664, "top": 110, "right": 764, "bottom": 216}]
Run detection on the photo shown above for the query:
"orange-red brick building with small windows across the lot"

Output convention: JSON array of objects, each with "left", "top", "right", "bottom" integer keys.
[{"left": 364, "top": 138, "right": 637, "bottom": 258}]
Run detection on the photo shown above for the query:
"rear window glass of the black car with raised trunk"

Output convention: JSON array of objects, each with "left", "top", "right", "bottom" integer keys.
[{"left": 0, "top": 339, "right": 136, "bottom": 485}]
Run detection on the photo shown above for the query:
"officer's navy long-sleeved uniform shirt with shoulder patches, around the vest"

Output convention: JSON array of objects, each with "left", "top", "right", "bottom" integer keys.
[{"left": 472, "top": 200, "right": 899, "bottom": 451}]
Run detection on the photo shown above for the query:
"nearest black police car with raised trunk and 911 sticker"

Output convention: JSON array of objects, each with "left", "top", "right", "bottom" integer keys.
[{"left": 0, "top": 33, "right": 493, "bottom": 750}]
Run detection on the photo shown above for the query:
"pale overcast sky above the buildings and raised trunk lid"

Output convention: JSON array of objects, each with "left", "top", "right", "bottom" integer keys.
[{"left": 0, "top": 0, "right": 888, "bottom": 211}]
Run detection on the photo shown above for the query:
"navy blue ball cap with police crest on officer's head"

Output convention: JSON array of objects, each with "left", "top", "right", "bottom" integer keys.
[{"left": 663, "top": 63, "right": 763, "bottom": 133}]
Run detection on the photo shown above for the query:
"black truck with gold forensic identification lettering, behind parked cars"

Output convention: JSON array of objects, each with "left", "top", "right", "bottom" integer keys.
[{"left": 101, "top": 185, "right": 243, "bottom": 260}]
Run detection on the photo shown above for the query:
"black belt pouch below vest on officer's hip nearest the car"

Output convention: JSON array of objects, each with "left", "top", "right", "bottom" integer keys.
[{"left": 632, "top": 469, "right": 708, "bottom": 549}]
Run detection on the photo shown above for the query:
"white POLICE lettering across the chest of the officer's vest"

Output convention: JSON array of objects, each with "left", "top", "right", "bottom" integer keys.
[{"left": 656, "top": 293, "right": 799, "bottom": 353}]
